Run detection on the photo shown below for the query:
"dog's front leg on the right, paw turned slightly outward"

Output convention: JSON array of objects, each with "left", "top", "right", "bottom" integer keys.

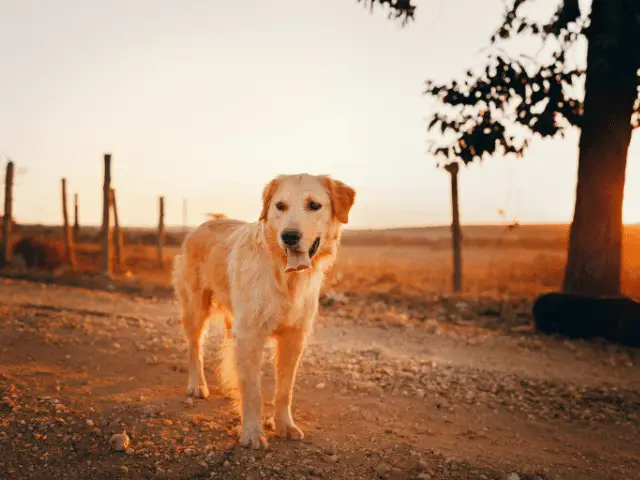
[{"left": 274, "top": 329, "right": 306, "bottom": 440}]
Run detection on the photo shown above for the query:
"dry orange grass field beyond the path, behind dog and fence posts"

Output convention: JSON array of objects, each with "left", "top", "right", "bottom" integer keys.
[{"left": 5, "top": 225, "right": 640, "bottom": 298}]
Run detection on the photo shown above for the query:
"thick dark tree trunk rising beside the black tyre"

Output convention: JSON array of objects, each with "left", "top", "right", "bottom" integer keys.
[{"left": 563, "top": 0, "right": 640, "bottom": 296}]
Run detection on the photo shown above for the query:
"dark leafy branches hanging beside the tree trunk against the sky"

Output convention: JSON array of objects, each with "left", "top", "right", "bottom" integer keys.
[{"left": 424, "top": 0, "right": 640, "bottom": 167}]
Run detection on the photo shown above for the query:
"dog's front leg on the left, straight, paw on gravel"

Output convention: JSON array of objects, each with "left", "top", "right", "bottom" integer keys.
[{"left": 235, "top": 335, "right": 267, "bottom": 448}]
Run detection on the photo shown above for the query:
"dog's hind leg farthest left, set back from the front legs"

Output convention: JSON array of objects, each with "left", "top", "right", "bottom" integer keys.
[{"left": 182, "top": 290, "right": 212, "bottom": 398}]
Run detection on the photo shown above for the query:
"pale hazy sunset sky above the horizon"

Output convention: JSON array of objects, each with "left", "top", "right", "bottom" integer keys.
[{"left": 0, "top": 0, "right": 640, "bottom": 227}]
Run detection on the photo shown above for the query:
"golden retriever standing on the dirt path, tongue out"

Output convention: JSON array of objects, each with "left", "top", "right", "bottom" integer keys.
[{"left": 173, "top": 174, "right": 355, "bottom": 448}]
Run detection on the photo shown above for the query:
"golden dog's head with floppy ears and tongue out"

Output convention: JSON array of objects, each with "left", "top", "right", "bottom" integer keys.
[{"left": 260, "top": 174, "right": 355, "bottom": 271}]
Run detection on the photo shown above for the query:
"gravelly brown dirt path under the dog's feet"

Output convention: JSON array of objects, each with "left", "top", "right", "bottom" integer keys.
[{"left": 0, "top": 280, "right": 640, "bottom": 480}]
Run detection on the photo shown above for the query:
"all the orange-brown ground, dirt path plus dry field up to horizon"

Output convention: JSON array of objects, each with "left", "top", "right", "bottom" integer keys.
[{"left": 0, "top": 226, "right": 640, "bottom": 480}]
